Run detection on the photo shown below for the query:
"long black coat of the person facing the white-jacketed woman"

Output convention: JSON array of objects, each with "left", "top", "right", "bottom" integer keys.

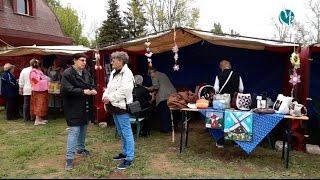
[{"left": 60, "top": 67, "right": 95, "bottom": 126}]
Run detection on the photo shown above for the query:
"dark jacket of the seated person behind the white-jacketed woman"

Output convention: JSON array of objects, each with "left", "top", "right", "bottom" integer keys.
[{"left": 133, "top": 84, "right": 152, "bottom": 109}]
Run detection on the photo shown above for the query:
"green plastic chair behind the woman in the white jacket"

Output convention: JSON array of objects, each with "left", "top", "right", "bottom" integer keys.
[{"left": 115, "top": 108, "right": 150, "bottom": 140}]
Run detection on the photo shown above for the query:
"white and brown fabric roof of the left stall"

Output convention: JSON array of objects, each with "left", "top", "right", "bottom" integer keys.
[{"left": 0, "top": 46, "right": 91, "bottom": 57}]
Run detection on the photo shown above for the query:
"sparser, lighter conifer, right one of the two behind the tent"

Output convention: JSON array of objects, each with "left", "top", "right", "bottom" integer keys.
[{"left": 124, "top": 0, "right": 147, "bottom": 38}]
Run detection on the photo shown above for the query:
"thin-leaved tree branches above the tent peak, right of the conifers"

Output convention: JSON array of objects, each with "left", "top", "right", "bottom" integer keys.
[{"left": 143, "top": 0, "right": 200, "bottom": 32}]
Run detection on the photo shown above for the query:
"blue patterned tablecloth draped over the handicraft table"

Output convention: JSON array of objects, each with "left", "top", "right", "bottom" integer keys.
[{"left": 199, "top": 108, "right": 284, "bottom": 154}]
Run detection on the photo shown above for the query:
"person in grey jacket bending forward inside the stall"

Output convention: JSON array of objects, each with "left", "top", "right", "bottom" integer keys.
[{"left": 148, "top": 68, "right": 177, "bottom": 133}]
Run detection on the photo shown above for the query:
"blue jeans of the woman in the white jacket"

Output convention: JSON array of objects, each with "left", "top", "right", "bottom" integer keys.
[{"left": 113, "top": 113, "right": 134, "bottom": 161}]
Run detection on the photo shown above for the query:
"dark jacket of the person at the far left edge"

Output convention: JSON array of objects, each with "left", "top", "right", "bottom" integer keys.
[{"left": 1, "top": 71, "right": 19, "bottom": 98}]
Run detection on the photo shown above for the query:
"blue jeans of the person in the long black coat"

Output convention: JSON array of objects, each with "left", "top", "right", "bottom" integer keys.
[{"left": 66, "top": 125, "right": 88, "bottom": 159}]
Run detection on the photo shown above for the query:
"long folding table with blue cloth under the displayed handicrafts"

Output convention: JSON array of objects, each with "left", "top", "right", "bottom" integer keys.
[{"left": 170, "top": 108, "right": 309, "bottom": 168}]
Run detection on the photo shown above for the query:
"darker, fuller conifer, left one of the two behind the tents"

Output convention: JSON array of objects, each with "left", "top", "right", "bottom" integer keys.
[{"left": 98, "top": 0, "right": 126, "bottom": 46}]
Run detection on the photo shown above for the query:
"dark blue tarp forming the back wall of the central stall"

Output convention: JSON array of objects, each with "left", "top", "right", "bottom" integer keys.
[{"left": 138, "top": 41, "right": 289, "bottom": 99}]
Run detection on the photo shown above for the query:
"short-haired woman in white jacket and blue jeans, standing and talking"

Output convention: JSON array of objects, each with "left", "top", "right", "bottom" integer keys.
[{"left": 102, "top": 51, "right": 134, "bottom": 169}]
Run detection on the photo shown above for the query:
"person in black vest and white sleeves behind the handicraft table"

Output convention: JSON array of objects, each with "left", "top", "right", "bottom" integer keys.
[{"left": 214, "top": 60, "right": 243, "bottom": 148}]
